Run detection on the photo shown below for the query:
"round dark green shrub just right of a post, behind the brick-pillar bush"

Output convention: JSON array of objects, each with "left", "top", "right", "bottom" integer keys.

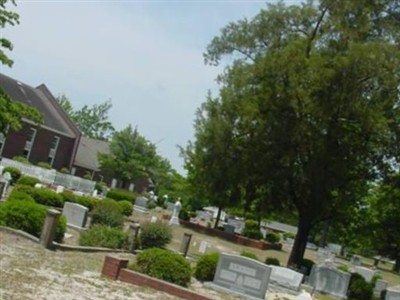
[{"left": 140, "top": 221, "right": 172, "bottom": 249}]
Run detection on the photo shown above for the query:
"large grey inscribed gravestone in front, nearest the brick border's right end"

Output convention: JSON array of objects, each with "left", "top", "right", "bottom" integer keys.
[{"left": 205, "top": 253, "right": 271, "bottom": 299}]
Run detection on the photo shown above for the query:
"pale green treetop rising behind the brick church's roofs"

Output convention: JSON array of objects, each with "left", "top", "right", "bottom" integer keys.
[{"left": 57, "top": 95, "right": 114, "bottom": 140}]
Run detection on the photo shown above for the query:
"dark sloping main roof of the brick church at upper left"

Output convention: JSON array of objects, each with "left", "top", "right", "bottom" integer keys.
[{"left": 0, "top": 73, "right": 79, "bottom": 137}]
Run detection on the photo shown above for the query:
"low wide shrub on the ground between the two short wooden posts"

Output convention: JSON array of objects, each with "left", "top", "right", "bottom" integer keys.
[{"left": 79, "top": 225, "right": 128, "bottom": 249}]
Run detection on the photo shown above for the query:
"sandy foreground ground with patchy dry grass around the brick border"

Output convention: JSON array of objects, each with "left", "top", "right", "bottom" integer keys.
[{"left": 0, "top": 231, "right": 302, "bottom": 300}]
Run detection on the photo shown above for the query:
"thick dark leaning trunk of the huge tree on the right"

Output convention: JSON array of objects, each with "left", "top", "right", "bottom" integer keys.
[{"left": 287, "top": 215, "right": 311, "bottom": 267}]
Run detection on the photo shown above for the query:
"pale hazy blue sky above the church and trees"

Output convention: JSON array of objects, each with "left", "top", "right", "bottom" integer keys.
[{"left": 0, "top": 0, "right": 299, "bottom": 174}]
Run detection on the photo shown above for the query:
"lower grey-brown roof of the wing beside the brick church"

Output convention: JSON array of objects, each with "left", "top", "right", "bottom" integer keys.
[{"left": 74, "top": 136, "right": 111, "bottom": 171}]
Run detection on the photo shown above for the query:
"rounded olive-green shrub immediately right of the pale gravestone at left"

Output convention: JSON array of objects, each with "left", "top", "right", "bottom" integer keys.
[{"left": 92, "top": 200, "right": 124, "bottom": 227}]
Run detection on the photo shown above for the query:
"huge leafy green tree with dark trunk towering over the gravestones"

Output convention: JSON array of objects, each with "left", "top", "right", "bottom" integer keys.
[{"left": 188, "top": 0, "right": 400, "bottom": 265}]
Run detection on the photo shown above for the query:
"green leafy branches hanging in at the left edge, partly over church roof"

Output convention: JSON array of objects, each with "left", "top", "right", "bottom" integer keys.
[{"left": 0, "top": 0, "right": 42, "bottom": 134}]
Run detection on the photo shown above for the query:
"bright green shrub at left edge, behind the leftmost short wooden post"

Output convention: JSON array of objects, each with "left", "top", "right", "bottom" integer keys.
[{"left": 0, "top": 201, "right": 66, "bottom": 242}]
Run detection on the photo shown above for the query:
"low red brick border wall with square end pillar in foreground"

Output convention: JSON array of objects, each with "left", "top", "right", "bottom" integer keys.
[{"left": 101, "top": 255, "right": 212, "bottom": 300}]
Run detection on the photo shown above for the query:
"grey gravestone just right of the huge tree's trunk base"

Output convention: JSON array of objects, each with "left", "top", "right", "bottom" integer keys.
[{"left": 308, "top": 265, "right": 350, "bottom": 298}]
